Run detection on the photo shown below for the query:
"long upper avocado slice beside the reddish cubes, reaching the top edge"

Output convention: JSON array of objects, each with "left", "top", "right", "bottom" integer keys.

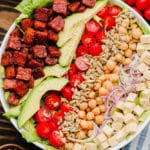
[{"left": 57, "top": 0, "right": 108, "bottom": 47}]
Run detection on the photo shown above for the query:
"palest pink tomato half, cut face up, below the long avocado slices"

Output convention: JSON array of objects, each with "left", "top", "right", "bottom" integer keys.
[{"left": 75, "top": 56, "right": 89, "bottom": 71}]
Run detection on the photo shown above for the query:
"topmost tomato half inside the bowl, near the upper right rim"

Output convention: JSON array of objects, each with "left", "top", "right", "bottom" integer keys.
[{"left": 108, "top": 6, "right": 122, "bottom": 16}]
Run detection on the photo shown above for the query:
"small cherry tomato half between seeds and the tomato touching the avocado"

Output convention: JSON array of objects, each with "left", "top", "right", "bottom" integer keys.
[{"left": 52, "top": 111, "right": 64, "bottom": 125}]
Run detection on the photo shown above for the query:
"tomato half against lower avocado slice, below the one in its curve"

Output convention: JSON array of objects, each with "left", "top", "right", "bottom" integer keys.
[{"left": 35, "top": 107, "right": 51, "bottom": 123}]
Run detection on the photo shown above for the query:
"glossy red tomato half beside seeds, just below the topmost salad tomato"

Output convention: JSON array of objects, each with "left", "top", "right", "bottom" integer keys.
[{"left": 103, "top": 15, "right": 116, "bottom": 30}]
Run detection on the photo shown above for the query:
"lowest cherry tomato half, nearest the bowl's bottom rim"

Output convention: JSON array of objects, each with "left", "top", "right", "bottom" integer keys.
[{"left": 49, "top": 130, "right": 66, "bottom": 147}]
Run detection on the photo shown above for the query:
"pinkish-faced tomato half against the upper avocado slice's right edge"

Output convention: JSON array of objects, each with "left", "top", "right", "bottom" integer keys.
[{"left": 85, "top": 20, "right": 100, "bottom": 35}]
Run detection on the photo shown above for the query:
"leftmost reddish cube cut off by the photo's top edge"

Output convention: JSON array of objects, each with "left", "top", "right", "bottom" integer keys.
[{"left": 52, "top": 0, "right": 67, "bottom": 16}]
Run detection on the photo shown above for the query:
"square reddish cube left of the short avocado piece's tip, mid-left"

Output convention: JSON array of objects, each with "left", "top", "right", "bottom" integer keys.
[{"left": 16, "top": 67, "right": 32, "bottom": 81}]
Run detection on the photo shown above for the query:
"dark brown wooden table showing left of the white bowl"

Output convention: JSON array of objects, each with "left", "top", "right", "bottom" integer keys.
[{"left": 0, "top": 0, "right": 39, "bottom": 150}]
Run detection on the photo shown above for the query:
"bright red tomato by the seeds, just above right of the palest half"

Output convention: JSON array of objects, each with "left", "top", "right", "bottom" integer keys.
[{"left": 88, "top": 43, "right": 102, "bottom": 56}]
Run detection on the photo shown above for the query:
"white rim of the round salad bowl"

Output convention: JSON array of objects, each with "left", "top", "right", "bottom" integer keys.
[{"left": 0, "top": 0, "right": 150, "bottom": 150}]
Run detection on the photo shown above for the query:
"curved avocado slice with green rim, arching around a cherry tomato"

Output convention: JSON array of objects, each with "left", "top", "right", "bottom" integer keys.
[{"left": 17, "top": 77, "right": 68, "bottom": 128}]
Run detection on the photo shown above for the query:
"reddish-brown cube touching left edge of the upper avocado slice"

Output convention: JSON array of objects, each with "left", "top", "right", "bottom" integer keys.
[{"left": 48, "top": 16, "right": 65, "bottom": 32}]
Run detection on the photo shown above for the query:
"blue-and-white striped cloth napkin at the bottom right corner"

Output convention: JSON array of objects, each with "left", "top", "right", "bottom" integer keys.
[{"left": 122, "top": 122, "right": 150, "bottom": 150}]
